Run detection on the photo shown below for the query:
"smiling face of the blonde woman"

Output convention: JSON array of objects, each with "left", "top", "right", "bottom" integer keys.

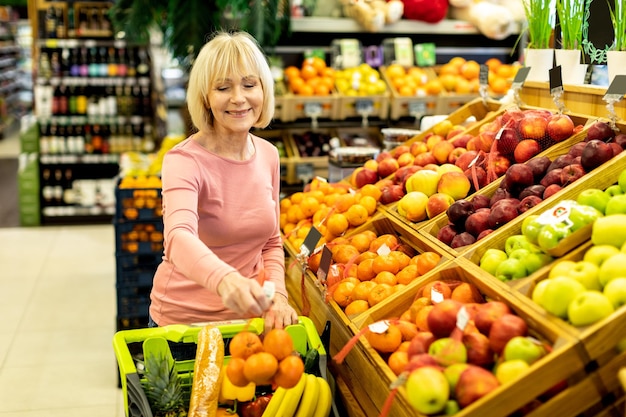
[{"left": 209, "top": 74, "right": 263, "bottom": 132}]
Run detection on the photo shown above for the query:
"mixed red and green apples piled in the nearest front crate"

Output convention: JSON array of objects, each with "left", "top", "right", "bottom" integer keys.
[{"left": 365, "top": 280, "right": 551, "bottom": 415}]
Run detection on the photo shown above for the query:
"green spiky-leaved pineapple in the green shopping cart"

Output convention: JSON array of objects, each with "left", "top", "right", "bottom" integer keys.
[{"left": 142, "top": 354, "right": 187, "bottom": 417}]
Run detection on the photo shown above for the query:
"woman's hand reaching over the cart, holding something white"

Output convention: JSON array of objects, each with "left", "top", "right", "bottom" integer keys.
[{"left": 217, "top": 272, "right": 272, "bottom": 318}]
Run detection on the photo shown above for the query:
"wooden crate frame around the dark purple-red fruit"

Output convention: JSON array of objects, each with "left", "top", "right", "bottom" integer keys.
[{"left": 414, "top": 115, "right": 596, "bottom": 259}]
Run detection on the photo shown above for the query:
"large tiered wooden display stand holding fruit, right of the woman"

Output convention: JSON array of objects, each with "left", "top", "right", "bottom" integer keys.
[{"left": 285, "top": 88, "right": 626, "bottom": 417}]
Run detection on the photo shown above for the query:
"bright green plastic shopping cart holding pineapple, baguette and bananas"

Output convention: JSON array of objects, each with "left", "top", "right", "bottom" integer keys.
[{"left": 113, "top": 317, "right": 328, "bottom": 417}]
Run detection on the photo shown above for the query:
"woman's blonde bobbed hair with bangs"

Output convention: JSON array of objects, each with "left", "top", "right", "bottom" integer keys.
[{"left": 187, "top": 31, "right": 274, "bottom": 132}]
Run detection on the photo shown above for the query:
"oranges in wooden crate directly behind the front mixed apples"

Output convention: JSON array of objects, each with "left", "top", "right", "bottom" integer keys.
[{"left": 307, "top": 230, "right": 441, "bottom": 316}]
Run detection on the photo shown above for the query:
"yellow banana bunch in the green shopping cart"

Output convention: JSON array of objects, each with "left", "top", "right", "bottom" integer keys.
[{"left": 263, "top": 373, "right": 333, "bottom": 417}]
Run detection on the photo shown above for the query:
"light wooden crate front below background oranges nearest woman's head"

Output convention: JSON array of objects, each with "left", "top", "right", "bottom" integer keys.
[{"left": 281, "top": 92, "right": 340, "bottom": 122}]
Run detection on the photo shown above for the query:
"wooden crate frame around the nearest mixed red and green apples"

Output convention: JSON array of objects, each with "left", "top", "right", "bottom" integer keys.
[{"left": 338, "top": 258, "right": 588, "bottom": 417}]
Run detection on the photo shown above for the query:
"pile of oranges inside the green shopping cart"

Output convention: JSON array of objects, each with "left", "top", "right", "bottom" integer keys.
[{"left": 226, "top": 328, "right": 304, "bottom": 388}]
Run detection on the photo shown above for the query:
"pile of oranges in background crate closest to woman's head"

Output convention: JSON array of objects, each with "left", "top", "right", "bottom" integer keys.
[{"left": 284, "top": 56, "right": 335, "bottom": 96}]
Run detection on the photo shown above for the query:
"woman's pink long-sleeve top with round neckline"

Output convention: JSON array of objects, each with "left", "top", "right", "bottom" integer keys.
[{"left": 150, "top": 136, "right": 287, "bottom": 326}]
